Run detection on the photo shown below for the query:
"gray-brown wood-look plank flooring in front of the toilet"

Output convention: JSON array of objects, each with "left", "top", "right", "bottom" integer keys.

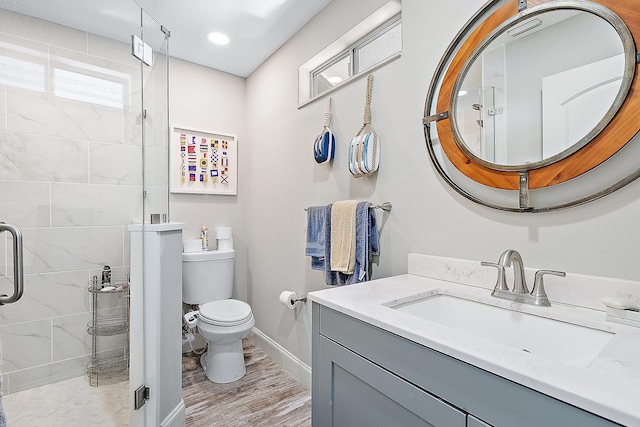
[{"left": 182, "top": 339, "right": 311, "bottom": 427}]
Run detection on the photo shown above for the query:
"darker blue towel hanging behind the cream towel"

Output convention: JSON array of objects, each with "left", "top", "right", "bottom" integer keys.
[{"left": 324, "top": 202, "right": 380, "bottom": 286}]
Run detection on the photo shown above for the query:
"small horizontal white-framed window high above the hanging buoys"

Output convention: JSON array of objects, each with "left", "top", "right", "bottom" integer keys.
[{"left": 298, "top": 0, "right": 402, "bottom": 106}]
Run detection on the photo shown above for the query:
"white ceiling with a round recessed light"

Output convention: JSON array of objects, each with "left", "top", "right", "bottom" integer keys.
[{"left": 0, "top": 0, "right": 331, "bottom": 77}]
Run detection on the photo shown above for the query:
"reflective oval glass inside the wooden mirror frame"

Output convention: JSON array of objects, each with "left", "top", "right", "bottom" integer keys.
[{"left": 452, "top": 9, "right": 625, "bottom": 167}]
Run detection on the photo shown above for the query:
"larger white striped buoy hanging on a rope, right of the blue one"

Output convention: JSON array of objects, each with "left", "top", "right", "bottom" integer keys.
[{"left": 349, "top": 74, "right": 380, "bottom": 178}]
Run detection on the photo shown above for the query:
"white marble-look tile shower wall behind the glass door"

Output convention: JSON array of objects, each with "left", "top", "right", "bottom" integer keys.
[{"left": 0, "top": 9, "right": 144, "bottom": 393}]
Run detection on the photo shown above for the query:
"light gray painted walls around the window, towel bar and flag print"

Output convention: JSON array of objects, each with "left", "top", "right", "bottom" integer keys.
[{"left": 170, "top": 0, "right": 640, "bottom": 372}]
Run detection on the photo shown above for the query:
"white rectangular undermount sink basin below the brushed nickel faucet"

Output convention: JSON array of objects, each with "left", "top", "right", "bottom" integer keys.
[{"left": 391, "top": 294, "right": 615, "bottom": 367}]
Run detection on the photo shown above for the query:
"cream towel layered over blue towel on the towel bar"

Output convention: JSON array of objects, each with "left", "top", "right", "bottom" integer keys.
[{"left": 331, "top": 200, "right": 358, "bottom": 274}]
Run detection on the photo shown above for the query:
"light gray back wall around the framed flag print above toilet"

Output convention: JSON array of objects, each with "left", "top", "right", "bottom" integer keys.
[{"left": 169, "top": 58, "right": 251, "bottom": 301}]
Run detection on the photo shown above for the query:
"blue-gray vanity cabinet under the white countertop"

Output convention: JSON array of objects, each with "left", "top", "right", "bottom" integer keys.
[{"left": 312, "top": 302, "right": 618, "bottom": 427}]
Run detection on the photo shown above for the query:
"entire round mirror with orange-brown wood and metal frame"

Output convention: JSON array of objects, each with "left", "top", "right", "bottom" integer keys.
[{"left": 423, "top": 0, "right": 640, "bottom": 212}]
